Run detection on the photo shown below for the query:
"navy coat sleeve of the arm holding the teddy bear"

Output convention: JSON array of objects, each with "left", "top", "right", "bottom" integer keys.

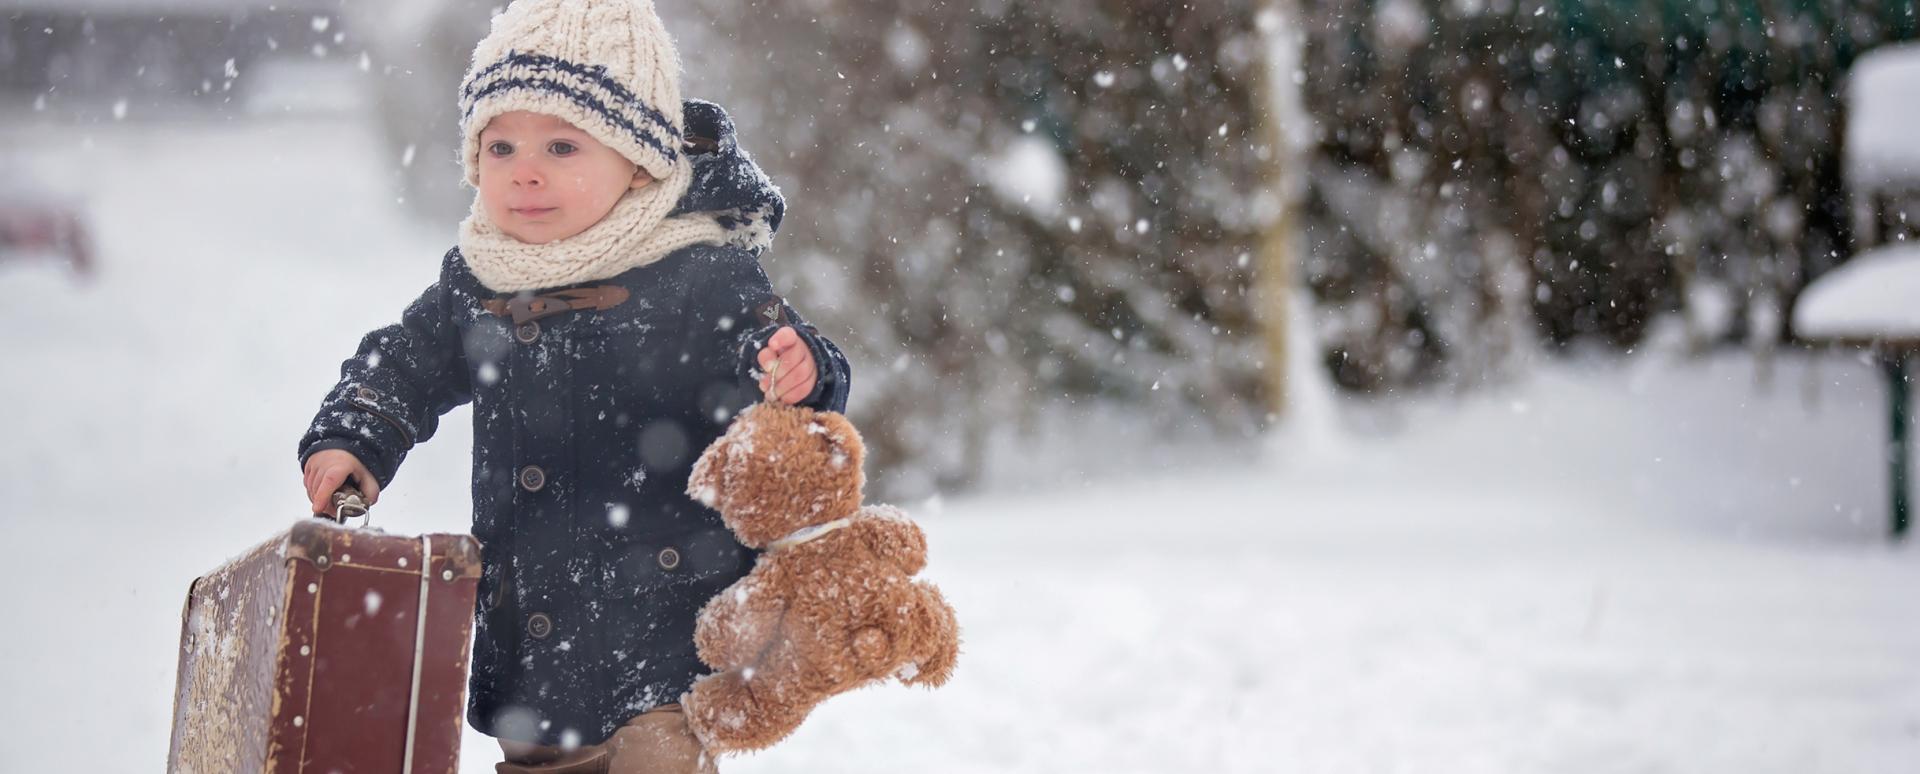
[{"left": 693, "top": 248, "right": 852, "bottom": 413}]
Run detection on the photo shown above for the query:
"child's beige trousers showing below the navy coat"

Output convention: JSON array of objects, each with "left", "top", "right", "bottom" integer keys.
[{"left": 493, "top": 705, "right": 718, "bottom": 774}]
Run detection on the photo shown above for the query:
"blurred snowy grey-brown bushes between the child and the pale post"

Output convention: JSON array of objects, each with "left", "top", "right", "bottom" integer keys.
[{"left": 680, "top": 0, "right": 1273, "bottom": 496}]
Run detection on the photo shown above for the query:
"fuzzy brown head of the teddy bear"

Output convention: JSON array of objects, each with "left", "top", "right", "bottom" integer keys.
[{"left": 687, "top": 403, "right": 866, "bottom": 547}]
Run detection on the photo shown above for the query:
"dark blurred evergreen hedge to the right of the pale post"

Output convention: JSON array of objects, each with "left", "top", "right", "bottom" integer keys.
[{"left": 1304, "top": 0, "right": 1916, "bottom": 390}]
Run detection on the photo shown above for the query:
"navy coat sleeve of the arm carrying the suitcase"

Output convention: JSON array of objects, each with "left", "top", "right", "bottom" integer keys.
[{"left": 300, "top": 254, "right": 472, "bottom": 488}]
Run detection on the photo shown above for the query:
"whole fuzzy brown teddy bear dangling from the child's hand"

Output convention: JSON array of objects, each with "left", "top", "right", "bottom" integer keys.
[{"left": 682, "top": 403, "right": 960, "bottom": 755}]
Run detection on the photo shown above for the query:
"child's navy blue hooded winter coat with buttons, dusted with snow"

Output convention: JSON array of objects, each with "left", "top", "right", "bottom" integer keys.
[{"left": 300, "top": 104, "right": 851, "bottom": 745}]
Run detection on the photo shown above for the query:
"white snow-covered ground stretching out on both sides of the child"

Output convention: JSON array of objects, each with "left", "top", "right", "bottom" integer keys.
[{"left": 0, "top": 117, "right": 1920, "bottom": 774}]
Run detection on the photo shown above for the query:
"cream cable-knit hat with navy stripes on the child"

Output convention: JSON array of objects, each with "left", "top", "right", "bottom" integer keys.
[{"left": 461, "top": 0, "right": 685, "bottom": 186}]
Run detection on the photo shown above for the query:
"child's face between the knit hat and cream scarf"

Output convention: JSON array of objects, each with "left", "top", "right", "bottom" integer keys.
[{"left": 480, "top": 109, "right": 653, "bottom": 244}]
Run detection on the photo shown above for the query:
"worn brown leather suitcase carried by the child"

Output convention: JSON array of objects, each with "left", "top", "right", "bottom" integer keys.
[{"left": 167, "top": 499, "right": 480, "bottom": 774}]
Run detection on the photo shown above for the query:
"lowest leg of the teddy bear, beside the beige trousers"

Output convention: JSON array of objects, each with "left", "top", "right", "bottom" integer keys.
[{"left": 685, "top": 670, "right": 812, "bottom": 755}]
